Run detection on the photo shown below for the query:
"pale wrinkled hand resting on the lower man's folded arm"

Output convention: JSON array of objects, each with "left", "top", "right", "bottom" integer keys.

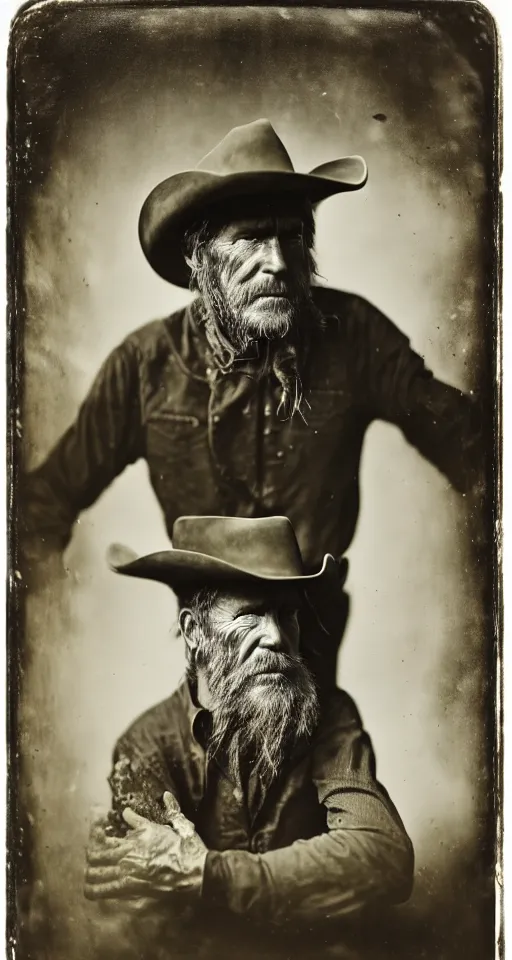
[{"left": 84, "top": 793, "right": 208, "bottom": 900}]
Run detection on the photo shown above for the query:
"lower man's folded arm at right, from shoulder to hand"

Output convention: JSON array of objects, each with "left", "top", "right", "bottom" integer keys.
[{"left": 87, "top": 690, "right": 413, "bottom": 925}]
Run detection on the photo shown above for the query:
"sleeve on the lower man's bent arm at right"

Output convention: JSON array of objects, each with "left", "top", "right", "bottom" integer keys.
[{"left": 203, "top": 691, "right": 413, "bottom": 924}]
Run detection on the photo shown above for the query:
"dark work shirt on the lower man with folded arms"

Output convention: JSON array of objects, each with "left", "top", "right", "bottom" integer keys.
[{"left": 110, "top": 682, "right": 413, "bottom": 940}]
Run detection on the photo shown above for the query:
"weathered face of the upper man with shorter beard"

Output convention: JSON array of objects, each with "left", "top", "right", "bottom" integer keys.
[{"left": 212, "top": 215, "right": 311, "bottom": 339}]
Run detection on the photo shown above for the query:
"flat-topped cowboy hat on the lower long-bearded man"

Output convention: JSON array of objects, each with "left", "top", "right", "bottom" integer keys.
[{"left": 107, "top": 517, "right": 348, "bottom": 593}]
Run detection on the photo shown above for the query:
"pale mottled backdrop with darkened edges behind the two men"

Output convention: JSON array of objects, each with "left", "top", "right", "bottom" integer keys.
[{"left": 11, "top": 4, "right": 494, "bottom": 960}]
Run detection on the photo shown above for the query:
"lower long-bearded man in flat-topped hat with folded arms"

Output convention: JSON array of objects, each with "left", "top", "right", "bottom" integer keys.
[{"left": 85, "top": 517, "right": 413, "bottom": 958}]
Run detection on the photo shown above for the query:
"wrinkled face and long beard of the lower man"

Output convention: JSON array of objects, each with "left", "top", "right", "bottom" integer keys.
[{"left": 185, "top": 584, "right": 318, "bottom": 783}]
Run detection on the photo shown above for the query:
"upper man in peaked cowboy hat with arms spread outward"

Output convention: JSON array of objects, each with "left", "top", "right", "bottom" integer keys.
[{"left": 21, "top": 120, "right": 481, "bottom": 676}]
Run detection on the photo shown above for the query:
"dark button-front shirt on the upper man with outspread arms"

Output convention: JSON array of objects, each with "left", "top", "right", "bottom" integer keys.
[{"left": 23, "top": 287, "right": 480, "bottom": 569}]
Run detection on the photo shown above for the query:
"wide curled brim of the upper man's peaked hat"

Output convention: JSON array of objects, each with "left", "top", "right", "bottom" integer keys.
[{"left": 139, "top": 156, "right": 368, "bottom": 288}]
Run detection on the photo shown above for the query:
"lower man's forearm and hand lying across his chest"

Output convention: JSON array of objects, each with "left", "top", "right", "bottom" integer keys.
[{"left": 86, "top": 790, "right": 413, "bottom": 924}]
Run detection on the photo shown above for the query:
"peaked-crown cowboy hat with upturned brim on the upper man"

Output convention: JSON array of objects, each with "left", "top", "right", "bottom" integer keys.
[{"left": 139, "top": 120, "right": 368, "bottom": 287}]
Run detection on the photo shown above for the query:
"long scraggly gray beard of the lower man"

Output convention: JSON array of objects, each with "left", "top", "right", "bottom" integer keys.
[{"left": 202, "top": 651, "right": 319, "bottom": 786}]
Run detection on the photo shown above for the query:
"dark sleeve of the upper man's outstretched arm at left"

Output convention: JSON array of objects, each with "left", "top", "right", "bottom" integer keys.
[{"left": 22, "top": 339, "right": 142, "bottom": 559}]
